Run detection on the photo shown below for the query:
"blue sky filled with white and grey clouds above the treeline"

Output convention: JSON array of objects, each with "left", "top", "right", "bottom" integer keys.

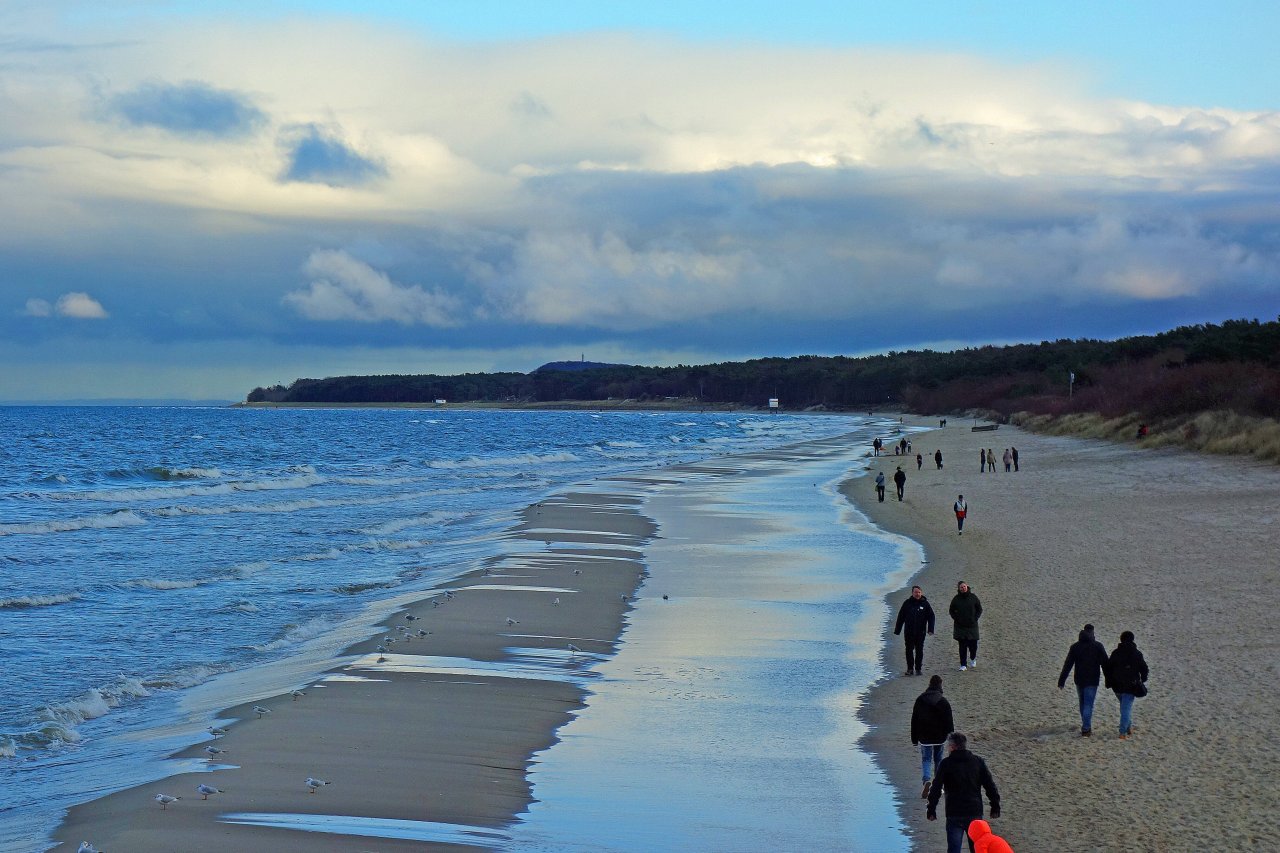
[{"left": 0, "top": 0, "right": 1280, "bottom": 401}]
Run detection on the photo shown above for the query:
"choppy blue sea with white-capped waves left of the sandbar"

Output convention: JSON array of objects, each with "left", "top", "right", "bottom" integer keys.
[{"left": 0, "top": 406, "right": 921, "bottom": 853}]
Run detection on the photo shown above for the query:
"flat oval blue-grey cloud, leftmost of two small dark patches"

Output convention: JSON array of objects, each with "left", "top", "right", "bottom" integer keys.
[{"left": 110, "top": 81, "right": 266, "bottom": 137}]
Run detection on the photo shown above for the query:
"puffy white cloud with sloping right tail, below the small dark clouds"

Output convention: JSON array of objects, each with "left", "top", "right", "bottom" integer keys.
[{"left": 284, "top": 250, "right": 461, "bottom": 328}]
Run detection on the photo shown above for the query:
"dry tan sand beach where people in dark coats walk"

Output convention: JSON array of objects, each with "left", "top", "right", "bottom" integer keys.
[{"left": 845, "top": 419, "right": 1280, "bottom": 852}]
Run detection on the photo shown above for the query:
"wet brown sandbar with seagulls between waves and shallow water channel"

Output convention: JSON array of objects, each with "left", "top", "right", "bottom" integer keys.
[{"left": 55, "top": 492, "right": 654, "bottom": 853}]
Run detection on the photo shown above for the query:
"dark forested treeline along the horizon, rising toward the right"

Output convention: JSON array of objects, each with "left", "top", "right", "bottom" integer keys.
[{"left": 247, "top": 320, "right": 1280, "bottom": 418}]
